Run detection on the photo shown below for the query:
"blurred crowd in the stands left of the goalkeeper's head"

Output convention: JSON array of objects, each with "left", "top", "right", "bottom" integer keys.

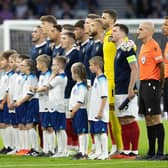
[{"left": 0, "top": 0, "right": 99, "bottom": 23}]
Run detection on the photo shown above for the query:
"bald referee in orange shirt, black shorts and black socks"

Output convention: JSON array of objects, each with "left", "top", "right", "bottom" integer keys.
[{"left": 137, "top": 22, "right": 165, "bottom": 160}]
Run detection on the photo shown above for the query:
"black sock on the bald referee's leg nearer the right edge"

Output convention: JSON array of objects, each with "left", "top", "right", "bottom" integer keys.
[{"left": 155, "top": 123, "right": 165, "bottom": 155}]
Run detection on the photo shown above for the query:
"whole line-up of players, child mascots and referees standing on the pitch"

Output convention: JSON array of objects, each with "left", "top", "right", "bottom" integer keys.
[{"left": 0, "top": 10, "right": 168, "bottom": 160}]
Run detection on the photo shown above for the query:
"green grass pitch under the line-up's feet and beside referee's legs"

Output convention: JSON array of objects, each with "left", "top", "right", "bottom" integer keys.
[{"left": 0, "top": 121, "right": 168, "bottom": 168}]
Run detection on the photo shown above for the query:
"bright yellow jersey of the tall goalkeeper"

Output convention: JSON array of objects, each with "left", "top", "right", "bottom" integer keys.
[{"left": 103, "top": 30, "right": 116, "bottom": 82}]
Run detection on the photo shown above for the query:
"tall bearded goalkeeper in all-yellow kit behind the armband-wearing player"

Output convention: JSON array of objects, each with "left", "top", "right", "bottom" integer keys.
[{"left": 102, "top": 10, "right": 122, "bottom": 155}]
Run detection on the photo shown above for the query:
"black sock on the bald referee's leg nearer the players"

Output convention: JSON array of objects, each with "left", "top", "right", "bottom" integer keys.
[{"left": 147, "top": 126, "right": 156, "bottom": 156}]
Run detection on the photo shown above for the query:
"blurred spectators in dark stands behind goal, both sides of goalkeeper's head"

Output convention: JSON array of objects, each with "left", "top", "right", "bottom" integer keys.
[{"left": 0, "top": 0, "right": 168, "bottom": 23}]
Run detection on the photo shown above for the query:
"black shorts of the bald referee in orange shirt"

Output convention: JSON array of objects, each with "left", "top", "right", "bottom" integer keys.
[{"left": 139, "top": 80, "right": 161, "bottom": 115}]
